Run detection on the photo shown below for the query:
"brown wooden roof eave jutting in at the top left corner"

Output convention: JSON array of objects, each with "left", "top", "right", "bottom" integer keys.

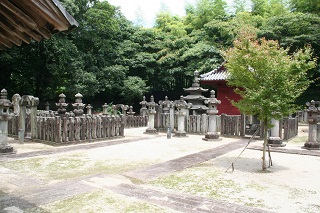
[{"left": 0, "top": 0, "right": 78, "bottom": 49}]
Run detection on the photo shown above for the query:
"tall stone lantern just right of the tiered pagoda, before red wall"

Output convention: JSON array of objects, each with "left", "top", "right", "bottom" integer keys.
[{"left": 202, "top": 90, "right": 221, "bottom": 141}]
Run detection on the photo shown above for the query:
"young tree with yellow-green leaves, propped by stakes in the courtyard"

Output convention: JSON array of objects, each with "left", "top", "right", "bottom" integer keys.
[{"left": 224, "top": 32, "right": 316, "bottom": 170}]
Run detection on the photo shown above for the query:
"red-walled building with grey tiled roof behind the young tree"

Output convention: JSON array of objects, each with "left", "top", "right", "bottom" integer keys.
[{"left": 200, "top": 62, "right": 241, "bottom": 115}]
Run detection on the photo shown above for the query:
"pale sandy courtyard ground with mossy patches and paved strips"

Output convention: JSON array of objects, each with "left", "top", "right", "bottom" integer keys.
[{"left": 0, "top": 127, "right": 320, "bottom": 212}]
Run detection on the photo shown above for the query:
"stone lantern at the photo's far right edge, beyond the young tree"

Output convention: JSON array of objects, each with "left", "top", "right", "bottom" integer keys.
[{"left": 303, "top": 100, "right": 320, "bottom": 149}]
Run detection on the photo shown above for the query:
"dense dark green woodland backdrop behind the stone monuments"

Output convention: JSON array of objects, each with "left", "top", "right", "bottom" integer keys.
[{"left": 0, "top": 0, "right": 320, "bottom": 109}]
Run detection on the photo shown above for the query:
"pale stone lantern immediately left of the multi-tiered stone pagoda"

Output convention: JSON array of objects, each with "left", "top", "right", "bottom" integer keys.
[{"left": 174, "top": 96, "right": 192, "bottom": 137}]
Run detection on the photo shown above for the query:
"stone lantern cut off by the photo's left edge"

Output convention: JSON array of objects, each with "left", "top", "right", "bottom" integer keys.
[{"left": 0, "top": 89, "right": 13, "bottom": 153}]
